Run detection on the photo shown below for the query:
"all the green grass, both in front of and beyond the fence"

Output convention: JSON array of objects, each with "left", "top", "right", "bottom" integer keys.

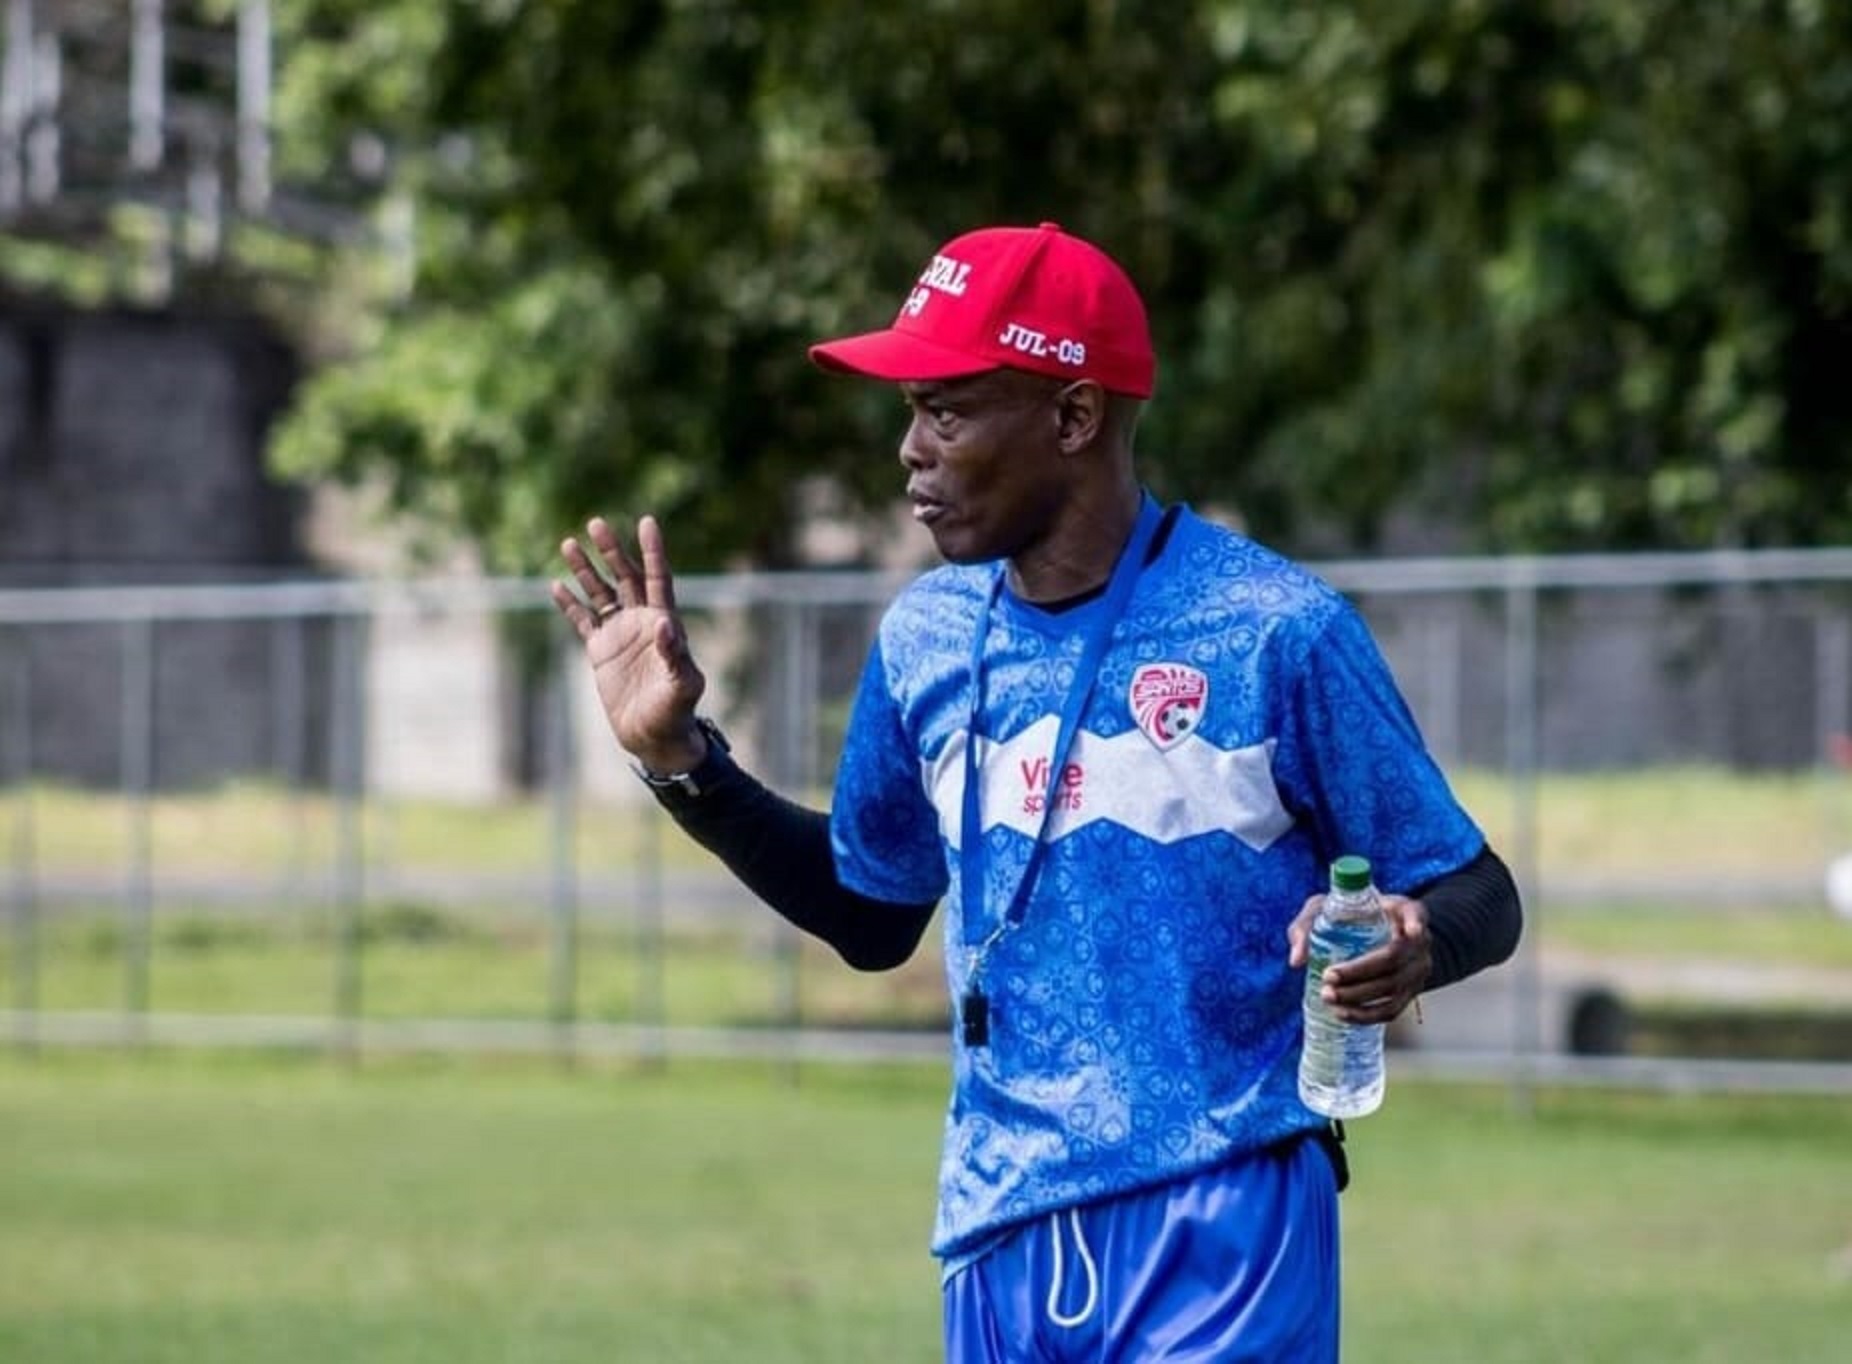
[{"left": 0, "top": 772, "right": 1852, "bottom": 1364}]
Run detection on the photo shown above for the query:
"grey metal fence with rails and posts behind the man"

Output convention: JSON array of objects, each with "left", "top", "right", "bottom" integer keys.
[{"left": 0, "top": 550, "right": 1852, "bottom": 1088}]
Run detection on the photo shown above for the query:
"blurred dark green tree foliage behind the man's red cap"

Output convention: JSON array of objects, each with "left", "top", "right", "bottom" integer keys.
[{"left": 14, "top": 0, "right": 1852, "bottom": 570}]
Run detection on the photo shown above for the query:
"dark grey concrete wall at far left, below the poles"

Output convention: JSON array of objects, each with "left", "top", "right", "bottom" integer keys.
[{"left": 0, "top": 298, "right": 328, "bottom": 787}]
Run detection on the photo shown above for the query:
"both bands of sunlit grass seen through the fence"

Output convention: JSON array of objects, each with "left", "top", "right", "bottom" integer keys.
[{"left": 0, "top": 768, "right": 1852, "bottom": 1025}]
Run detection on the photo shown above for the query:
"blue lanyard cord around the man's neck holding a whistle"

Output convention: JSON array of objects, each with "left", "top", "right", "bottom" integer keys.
[{"left": 959, "top": 494, "right": 1163, "bottom": 954}]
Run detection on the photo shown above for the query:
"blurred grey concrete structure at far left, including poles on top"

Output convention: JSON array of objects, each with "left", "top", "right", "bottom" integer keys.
[{"left": 0, "top": 0, "right": 407, "bottom": 787}]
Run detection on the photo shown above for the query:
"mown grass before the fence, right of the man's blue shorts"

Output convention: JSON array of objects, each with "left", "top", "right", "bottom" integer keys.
[{"left": 1346, "top": 1092, "right": 1852, "bottom": 1364}]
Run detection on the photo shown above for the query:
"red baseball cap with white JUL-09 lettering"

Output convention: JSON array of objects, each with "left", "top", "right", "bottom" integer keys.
[{"left": 809, "top": 222, "right": 1158, "bottom": 398}]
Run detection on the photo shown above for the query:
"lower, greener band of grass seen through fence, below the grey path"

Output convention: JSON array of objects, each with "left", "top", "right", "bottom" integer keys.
[{"left": 14, "top": 903, "right": 1852, "bottom": 1027}]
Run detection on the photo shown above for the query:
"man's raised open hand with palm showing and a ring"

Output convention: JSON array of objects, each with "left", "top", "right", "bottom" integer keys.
[{"left": 552, "top": 516, "right": 707, "bottom": 772}]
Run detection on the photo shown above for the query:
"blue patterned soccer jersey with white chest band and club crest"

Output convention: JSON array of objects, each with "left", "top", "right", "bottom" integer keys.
[{"left": 832, "top": 509, "right": 1485, "bottom": 1259}]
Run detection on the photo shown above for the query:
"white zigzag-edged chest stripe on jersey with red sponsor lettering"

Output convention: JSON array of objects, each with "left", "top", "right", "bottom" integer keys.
[{"left": 922, "top": 714, "right": 1293, "bottom": 849}]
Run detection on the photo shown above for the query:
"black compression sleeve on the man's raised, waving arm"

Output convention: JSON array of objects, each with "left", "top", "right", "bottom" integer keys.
[{"left": 656, "top": 746, "right": 935, "bottom": 972}]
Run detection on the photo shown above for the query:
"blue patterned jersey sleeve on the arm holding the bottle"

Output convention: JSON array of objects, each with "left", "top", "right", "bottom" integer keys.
[{"left": 1276, "top": 601, "right": 1485, "bottom": 894}]
